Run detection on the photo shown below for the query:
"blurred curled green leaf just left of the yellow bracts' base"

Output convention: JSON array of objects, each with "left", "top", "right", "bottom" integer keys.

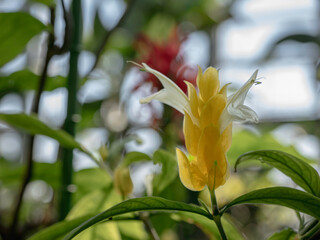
[{"left": 152, "top": 150, "right": 178, "bottom": 195}]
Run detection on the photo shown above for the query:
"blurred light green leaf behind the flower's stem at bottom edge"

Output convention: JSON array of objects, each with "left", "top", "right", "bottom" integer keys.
[{"left": 171, "top": 212, "right": 245, "bottom": 240}]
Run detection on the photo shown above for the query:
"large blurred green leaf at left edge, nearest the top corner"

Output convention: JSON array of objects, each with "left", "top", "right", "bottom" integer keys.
[{"left": 0, "top": 12, "right": 46, "bottom": 67}]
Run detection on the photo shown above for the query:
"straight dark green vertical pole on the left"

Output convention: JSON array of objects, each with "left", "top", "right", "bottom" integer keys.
[{"left": 59, "top": 0, "right": 81, "bottom": 220}]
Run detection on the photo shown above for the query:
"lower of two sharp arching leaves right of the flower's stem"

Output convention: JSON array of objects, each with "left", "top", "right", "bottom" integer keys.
[{"left": 221, "top": 187, "right": 320, "bottom": 219}]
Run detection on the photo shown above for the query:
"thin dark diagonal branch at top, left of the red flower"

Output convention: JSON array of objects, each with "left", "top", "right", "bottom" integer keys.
[{"left": 89, "top": 0, "right": 134, "bottom": 73}]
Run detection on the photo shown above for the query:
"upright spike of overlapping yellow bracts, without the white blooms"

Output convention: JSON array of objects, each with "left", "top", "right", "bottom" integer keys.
[{"left": 176, "top": 67, "right": 232, "bottom": 191}]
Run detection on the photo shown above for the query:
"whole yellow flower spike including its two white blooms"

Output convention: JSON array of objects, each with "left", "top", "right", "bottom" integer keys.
[{"left": 140, "top": 64, "right": 259, "bottom": 191}]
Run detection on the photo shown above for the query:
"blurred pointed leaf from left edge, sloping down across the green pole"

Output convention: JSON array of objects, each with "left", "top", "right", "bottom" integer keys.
[{"left": 0, "top": 113, "right": 82, "bottom": 150}]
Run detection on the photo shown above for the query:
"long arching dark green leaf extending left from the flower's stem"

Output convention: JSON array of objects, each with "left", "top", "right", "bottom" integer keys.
[{"left": 64, "top": 197, "right": 212, "bottom": 240}]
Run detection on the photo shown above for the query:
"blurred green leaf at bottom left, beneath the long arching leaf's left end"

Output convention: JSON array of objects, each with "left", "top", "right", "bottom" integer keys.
[{"left": 28, "top": 214, "right": 93, "bottom": 240}]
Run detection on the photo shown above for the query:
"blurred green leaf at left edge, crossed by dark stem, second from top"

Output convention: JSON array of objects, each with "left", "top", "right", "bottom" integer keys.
[{"left": 0, "top": 69, "right": 66, "bottom": 96}]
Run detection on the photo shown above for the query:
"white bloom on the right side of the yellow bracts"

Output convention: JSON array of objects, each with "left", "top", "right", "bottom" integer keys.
[{"left": 220, "top": 70, "right": 260, "bottom": 132}]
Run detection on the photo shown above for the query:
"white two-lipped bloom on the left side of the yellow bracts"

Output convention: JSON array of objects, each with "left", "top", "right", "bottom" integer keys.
[{"left": 140, "top": 63, "right": 199, "bottom": 125}]
